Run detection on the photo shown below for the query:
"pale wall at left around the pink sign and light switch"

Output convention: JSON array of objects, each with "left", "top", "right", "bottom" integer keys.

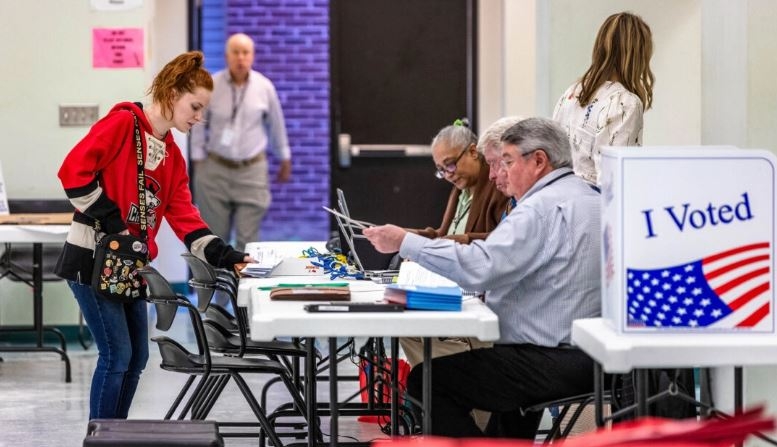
[{"left": 0, "top": 0, "right": 186, "bottom": 324}]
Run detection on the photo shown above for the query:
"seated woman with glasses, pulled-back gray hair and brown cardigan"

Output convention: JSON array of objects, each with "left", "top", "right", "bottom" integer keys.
[{"left": 411, "top": 119, "right": 508, "bottom": 244}]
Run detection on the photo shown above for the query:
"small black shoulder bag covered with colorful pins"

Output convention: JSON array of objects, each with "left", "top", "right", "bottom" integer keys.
[{"left": 92, "top": 234, "right": 148, "bottom": 302}]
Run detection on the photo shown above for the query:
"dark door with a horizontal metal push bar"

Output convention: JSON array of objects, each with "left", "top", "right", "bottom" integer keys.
[{"left": 330, "top": 0, "right": 477, "bottom": 227}]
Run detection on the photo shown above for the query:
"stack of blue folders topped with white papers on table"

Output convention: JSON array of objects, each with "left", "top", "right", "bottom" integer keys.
[{"left": 384, "top": 261, "right": 462, "bottom": 311}]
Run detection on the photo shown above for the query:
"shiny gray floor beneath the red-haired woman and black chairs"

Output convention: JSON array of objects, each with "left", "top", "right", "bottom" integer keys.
[{"left": 0, "top": 317, "right": 387, "bottom": 447}]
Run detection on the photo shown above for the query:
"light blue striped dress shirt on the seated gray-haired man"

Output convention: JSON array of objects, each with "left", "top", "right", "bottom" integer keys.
[{"left": 399, "top": 168, "right": 601, "bottom": 347}]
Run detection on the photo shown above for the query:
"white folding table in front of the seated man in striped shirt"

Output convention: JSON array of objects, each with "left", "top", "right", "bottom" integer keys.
[{"left": 238, "top": 276, "right": 499, "bottom": 446}]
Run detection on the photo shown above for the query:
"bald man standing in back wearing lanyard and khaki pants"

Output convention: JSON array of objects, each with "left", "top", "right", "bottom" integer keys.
[{"left": 191, "top": 34, "right": 291, "bottom": 250}]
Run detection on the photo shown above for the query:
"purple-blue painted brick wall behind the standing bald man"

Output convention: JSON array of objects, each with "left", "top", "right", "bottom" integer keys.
[{"left": 202, "top": 0, "right": 329, "bottom": 240}]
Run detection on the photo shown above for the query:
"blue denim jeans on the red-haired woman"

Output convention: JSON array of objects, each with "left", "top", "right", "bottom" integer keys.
[{"left": 68, "top": 281, "right": 148, "bottom": 419}]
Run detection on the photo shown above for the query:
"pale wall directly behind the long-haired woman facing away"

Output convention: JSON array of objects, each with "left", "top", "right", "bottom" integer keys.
[{"left": 548, "top": 0, "right": 701, "bottom": 145}]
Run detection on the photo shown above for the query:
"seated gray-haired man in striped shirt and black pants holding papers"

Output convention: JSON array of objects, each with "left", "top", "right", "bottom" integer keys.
[{"left": 364, "top": 118, "right": 601, "bottom": 438}]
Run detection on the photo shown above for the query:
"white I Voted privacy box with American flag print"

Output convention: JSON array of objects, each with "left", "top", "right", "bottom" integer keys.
[{"left": 600, "top": 146, "right": 777, "bottom": 334}]
